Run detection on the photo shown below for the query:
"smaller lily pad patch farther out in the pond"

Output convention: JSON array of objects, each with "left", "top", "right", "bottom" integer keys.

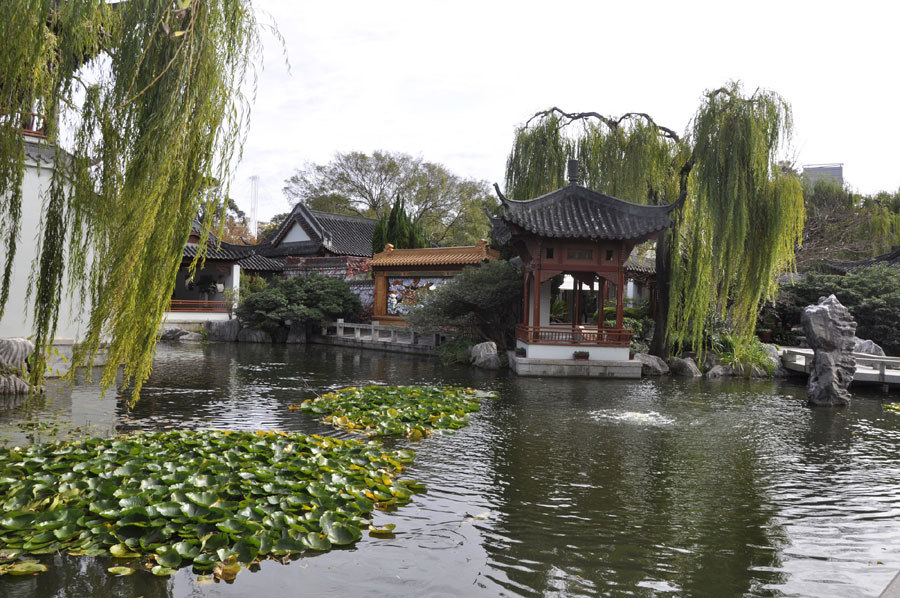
[{"left": 300, "top": 386, "right": 497, "bottom": 440}]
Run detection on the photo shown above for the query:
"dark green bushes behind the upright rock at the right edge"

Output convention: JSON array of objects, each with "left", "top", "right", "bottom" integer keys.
[{"left": 776, "top": 264, "right": 900, "bottom": 355}]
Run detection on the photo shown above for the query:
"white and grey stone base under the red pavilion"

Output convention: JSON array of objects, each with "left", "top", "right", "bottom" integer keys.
[{"left": 509, "top": 342, "right": 641, "bottom": 378}]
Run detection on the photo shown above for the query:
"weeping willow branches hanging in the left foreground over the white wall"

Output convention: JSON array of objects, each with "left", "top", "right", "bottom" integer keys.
[{"left": 0, "top": 0, "right": 261, "bottom": 398}]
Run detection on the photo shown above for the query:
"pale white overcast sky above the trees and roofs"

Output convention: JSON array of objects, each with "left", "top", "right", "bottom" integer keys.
[{"left": 232, "top": 0, "right": 900, "bottom": 225}]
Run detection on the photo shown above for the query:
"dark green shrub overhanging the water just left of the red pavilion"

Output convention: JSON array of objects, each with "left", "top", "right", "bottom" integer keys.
[{"left": 406, "top": 260, "right": 522, "bottom": 351}]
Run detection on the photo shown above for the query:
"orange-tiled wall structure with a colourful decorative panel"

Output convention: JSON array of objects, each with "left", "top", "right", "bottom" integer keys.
[{"left": 372, "top": 239, "right": 500, "bottom": 324}]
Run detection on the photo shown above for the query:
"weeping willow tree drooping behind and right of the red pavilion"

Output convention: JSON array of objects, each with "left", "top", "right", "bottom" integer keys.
[{"left": 506, "top": 83, "right": 805, "bottom": 354}]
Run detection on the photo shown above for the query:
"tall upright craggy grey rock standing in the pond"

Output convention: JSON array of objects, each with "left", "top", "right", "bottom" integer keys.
[{"left": 800, "top": 295, "right": 856, "bottom": 407}]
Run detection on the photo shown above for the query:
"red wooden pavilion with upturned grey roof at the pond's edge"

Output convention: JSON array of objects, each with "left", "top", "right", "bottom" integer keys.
[{"left": 492, "top": 160, "right": 673, "bottom": 377}]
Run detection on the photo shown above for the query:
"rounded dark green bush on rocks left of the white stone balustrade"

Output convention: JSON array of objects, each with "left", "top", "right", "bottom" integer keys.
[{"left": 235, "top": 273, "right": 362, "bottom": 332}]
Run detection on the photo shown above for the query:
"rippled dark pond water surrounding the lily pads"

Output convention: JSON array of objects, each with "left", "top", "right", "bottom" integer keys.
[{"left": 0, "top": 344, "right": 900, "bottom": 598}]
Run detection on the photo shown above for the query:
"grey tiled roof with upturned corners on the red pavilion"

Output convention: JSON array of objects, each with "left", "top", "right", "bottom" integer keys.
[{"left": 494, "top": 184, "right": 675, "bottom": 242}]
